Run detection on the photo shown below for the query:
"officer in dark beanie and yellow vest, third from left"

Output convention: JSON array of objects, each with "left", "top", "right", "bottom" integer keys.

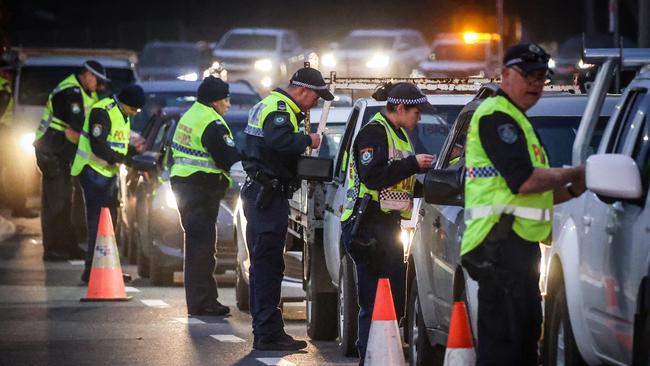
[{"left": 171, "top": 76, "right": 241, "bottom": 316}]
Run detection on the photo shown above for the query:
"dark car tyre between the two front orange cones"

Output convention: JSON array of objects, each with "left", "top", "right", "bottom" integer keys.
[{"left": 405, "top": 276, "right": 444, "bottom": 366}]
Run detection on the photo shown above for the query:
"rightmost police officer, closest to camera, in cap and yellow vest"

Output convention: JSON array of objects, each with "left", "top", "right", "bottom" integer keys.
[{"left": 461, "top": 44, "right": 585, "bottom": 365}]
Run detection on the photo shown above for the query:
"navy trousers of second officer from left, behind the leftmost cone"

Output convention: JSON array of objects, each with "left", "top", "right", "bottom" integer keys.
[{"left": 79, "top": 166, "right": 117, "bottom": 270}]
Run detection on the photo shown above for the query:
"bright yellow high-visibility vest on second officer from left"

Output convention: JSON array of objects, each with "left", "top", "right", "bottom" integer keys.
[{"left": 70, "top": 97, "right": 131, "bottom": 178}]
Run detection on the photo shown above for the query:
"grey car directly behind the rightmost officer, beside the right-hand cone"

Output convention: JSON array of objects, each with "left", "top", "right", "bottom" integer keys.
[{"left": 404, "top": 85, "right": 618, "bottom": 365}]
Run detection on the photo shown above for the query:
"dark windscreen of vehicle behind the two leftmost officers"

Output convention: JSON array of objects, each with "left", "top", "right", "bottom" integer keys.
[{"left": 18, "top": 66, "right": 135, "bottom": 106}]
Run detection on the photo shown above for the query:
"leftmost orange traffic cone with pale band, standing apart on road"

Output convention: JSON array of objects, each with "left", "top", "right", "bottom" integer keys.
[{"left": 81, "top": 207, "right": 131, "bottom": 301}]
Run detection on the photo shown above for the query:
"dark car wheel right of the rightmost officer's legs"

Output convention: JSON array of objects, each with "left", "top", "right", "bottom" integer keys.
[{"left": 544, "top": 283, "right": 586, "bottom": 366}]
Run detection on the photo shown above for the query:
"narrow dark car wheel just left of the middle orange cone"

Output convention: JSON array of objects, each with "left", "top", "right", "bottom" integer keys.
[{"left": 337, "top": 254, "right": 359, "bottom": 357}]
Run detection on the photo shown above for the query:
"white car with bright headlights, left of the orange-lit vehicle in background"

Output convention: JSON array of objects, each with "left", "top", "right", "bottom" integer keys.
[{"left": 319, "top": 29, "right": 430, "bottom": 77}]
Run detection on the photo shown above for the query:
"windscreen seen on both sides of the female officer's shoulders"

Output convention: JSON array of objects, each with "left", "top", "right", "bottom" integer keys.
[{"left": 362, "top": 105, "right": 463, "bottom": 156}]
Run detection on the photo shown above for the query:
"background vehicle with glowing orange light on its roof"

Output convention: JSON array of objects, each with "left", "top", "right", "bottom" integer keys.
[{"left": 418, "top": 32, "right": 501, "bottom": 78}]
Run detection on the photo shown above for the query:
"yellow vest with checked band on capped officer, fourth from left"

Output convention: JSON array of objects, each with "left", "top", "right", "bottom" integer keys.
[{"left": 244, "top": 91, "right": 300, "bottom": 137}]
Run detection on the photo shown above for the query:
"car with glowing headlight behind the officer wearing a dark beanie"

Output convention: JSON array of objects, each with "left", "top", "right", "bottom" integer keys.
[{"left": 116, "top": 81, "right": 261, "bottom": 285}]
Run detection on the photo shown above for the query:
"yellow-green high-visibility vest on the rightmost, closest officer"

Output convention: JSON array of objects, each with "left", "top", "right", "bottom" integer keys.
[{"left": 461, "top": 96, "right": 553, "bottom": 255}]
